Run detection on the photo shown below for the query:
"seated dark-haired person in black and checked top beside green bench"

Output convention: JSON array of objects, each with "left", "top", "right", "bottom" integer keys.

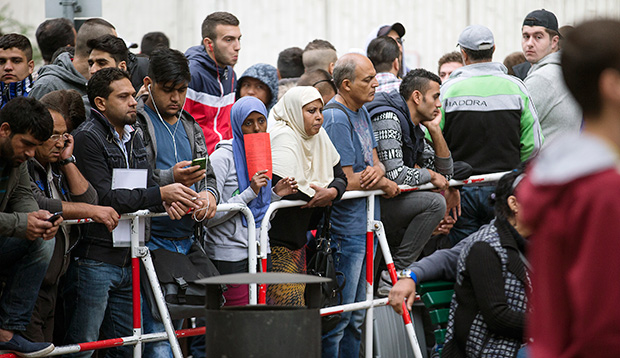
[{"left": 442, "top": 171, "right": 530, "bottom": 358}]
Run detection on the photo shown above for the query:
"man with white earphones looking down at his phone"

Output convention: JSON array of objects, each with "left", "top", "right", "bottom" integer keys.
[{"left": 137, "top": 49, "right": 218, "bottom": 357}]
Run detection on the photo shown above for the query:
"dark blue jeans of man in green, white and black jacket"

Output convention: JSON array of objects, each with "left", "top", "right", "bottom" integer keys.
[{"left": 448, "top": 185, "right": 495, "bottom": 246}]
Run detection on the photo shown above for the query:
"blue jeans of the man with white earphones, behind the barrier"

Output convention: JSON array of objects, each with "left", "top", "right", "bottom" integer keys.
[{"left": 142, "top": 236, "right": 194, "bottom": 358}]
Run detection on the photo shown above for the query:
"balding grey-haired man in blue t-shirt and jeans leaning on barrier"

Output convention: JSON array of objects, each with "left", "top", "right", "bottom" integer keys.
[{"left": 322, "top": 54, "right": 400, "bottom": 358}]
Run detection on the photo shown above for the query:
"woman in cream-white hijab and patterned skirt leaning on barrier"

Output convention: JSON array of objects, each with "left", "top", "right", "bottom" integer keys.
[{"left": 267, "top": 87, "right": 347, "bottom": 306}]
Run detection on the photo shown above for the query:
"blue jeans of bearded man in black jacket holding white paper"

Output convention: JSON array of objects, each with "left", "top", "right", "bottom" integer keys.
[{"left": 64, "top": 258, "right": 133, "bottom": 357}]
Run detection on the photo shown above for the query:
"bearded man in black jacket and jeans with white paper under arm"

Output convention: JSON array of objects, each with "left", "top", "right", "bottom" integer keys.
[{"left": 64, "top": 68, "right": 204, "bottom": 357}]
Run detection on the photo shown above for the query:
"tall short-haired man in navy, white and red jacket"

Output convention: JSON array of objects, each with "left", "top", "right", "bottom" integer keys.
[{"left": 184, "top": 12, "right": 241, "bottom": 153}]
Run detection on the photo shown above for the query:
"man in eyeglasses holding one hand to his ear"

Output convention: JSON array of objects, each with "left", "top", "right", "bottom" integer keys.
[{"left": 24, "top": 92, "right": 119, "bottom": 342}]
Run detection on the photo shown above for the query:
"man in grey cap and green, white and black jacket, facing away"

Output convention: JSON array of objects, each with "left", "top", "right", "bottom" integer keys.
[{"left": 440, "top": 25, "right": 543, "bottom": 245}]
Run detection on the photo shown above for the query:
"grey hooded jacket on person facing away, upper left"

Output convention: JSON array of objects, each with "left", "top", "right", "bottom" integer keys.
[{"left": 30, "top": 52, "right": 88, "bottom": 99}]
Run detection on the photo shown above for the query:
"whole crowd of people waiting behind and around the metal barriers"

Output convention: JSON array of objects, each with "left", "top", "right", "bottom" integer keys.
[{"left": 0, "top": 9, "right": 620, "bottom": 358}]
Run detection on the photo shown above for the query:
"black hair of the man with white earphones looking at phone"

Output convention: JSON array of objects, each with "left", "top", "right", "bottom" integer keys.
[{"left": 148, "top": 48, "right": 192, "bottom": 86}]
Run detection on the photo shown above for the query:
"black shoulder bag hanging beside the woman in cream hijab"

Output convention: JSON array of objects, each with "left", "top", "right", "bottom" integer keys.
[{"left": 306, "top": 206, "right": 346, "bottom": 334}]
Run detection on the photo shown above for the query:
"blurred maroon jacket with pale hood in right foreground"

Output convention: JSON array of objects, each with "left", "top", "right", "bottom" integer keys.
[{"left": 516, "top": 134, "right": 620, "bottom": 358}]
